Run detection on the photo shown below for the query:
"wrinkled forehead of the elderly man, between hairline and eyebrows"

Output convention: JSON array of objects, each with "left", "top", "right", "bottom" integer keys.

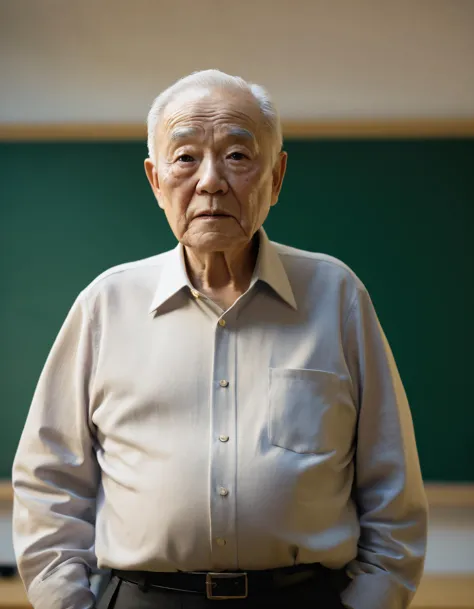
[{"left": 158, "top": 89, "right": 264, "bottom": 143}]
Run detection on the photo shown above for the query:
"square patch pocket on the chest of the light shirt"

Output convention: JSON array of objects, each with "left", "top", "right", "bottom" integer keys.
[{"left": 268, "top": 368, "right": 345, "bottom": 453}]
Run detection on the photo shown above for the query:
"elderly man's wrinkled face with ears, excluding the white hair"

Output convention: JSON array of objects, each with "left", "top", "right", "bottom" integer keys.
[{"left": 145, "top": 89, "right": 286, "bottom": 252}]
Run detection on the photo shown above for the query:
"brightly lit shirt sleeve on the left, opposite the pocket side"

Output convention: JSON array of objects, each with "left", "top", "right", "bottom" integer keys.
[{"left": 13, "top": 296, "right": 99, "bottom": 609}]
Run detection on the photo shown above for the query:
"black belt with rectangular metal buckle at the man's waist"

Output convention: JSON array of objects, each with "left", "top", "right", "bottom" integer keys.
[{"left": 112, "top": 563, "right": 331, "bottom": 600}]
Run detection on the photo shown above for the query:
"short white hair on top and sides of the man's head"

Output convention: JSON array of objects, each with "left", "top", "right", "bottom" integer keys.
[{"left": 147, "top": 70, "right": 283, "bottom": 165}]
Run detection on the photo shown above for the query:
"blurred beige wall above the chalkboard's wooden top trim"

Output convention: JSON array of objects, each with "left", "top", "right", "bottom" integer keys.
[{"left": 0, "top": 0, "right": 474, "bottom": 123}]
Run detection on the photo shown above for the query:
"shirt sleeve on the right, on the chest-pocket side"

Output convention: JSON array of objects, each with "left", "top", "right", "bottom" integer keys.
[{"left": 343, "top": 288, "right": 427, "bottom": 609}]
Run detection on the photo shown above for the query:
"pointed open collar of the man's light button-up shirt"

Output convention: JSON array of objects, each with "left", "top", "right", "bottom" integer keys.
[{"left": 149, "top": 228, "right": 297, "bottom": 313}]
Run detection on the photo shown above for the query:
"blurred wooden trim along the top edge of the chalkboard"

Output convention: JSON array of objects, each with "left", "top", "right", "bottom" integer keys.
[{"left": 0, "top": 117, "right": 474, "bottom": 142}]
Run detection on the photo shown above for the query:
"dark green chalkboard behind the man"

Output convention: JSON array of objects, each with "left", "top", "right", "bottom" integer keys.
[{"left": 0, "top": 139, "right": 474, "bottom": 482}]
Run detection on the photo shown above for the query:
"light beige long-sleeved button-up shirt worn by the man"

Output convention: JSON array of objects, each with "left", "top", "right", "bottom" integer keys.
[{"left": 13, "top": 230, "right": 426, "bottom": 609}]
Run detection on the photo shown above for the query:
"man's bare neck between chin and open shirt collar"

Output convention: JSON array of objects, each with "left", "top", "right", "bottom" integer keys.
[{"left": 184, "top": 235, "right": 258, "bottom": 309}]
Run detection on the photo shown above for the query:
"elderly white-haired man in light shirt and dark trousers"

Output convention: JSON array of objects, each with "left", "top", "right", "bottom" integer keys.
[{"left": 13, "top": 70, "right": 426, "bottom": 609}]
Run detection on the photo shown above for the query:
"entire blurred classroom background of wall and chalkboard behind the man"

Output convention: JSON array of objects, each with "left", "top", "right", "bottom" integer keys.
[{"left": 0, "top": 0, "right": 474, "bottom": 609}]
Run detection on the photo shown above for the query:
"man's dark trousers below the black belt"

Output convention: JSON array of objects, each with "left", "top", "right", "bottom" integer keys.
[{"left": 97, "top": 576, "right": 347, "bottom": 609}]
